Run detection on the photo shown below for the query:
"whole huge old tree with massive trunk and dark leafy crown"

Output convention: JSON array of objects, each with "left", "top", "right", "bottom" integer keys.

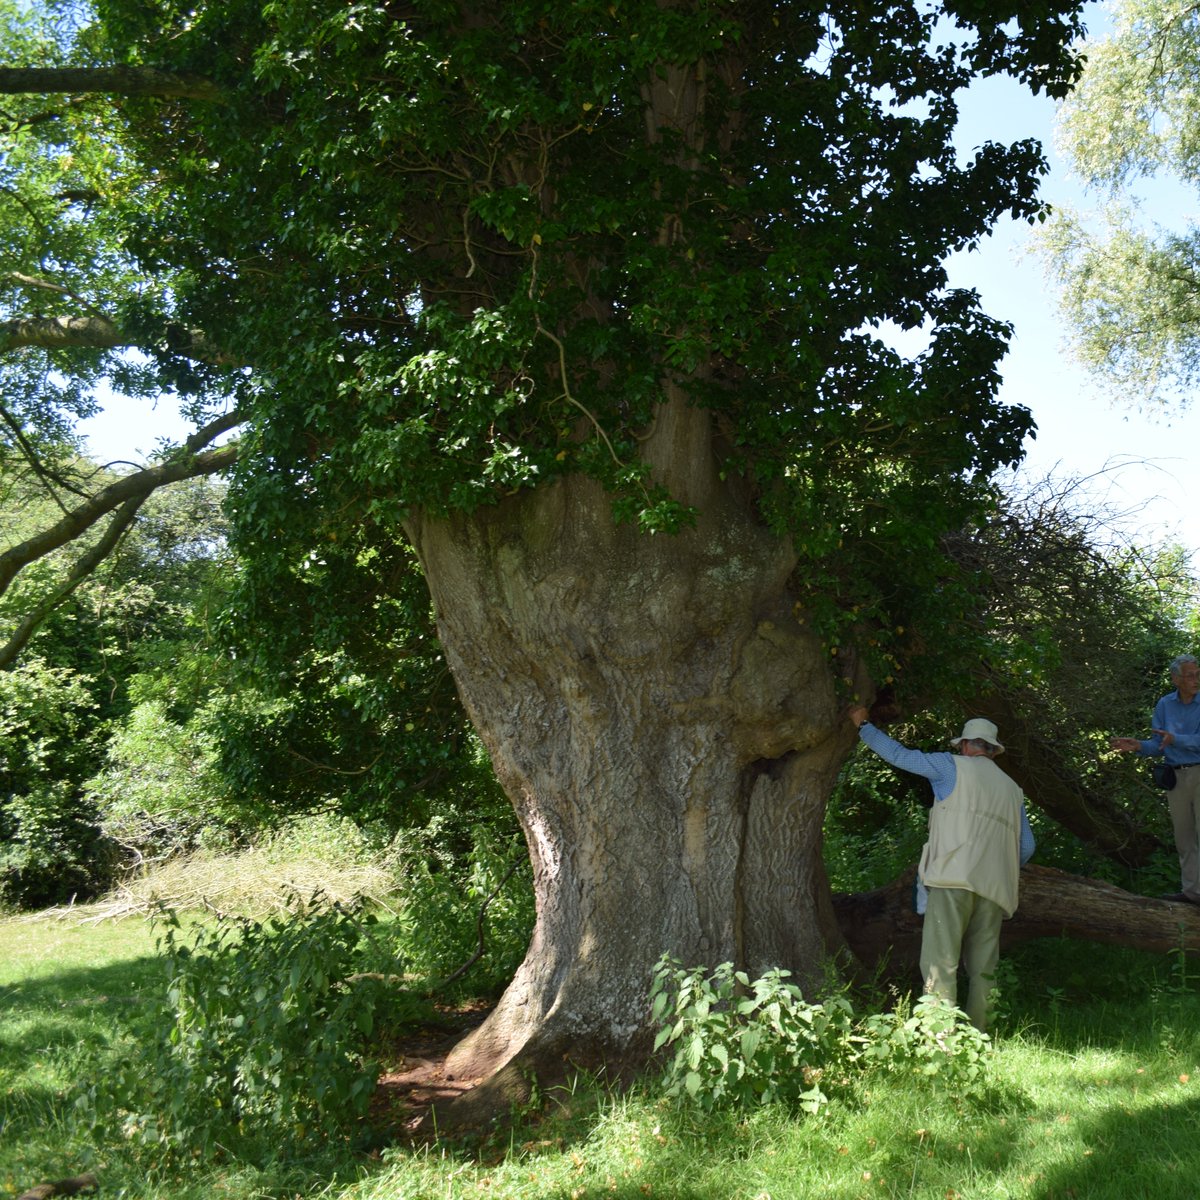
[{"left": 0, "top": 0, "right": 1079, "bottom": 1094}]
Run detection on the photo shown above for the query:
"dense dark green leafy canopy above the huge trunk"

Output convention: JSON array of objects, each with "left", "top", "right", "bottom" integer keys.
[{"left": 4, "top": 2, "right": 1078, "bottom": 676}]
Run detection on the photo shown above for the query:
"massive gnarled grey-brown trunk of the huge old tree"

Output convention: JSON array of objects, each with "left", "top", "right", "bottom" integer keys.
[{"left": 409, "top": 446, "right": 853, "bottom": 1094}]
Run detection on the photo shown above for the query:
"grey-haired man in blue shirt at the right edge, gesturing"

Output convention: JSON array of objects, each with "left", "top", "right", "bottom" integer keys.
[{"left": 1109, "top": 654, "right": 1200, "bottom": 904}]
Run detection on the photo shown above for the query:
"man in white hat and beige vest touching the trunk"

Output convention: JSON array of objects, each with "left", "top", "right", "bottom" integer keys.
[{"left": 848, "top": 706, "right": 1034, "bottom": 1030}]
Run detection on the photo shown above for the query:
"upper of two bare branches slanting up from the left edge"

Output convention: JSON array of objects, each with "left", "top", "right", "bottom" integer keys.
[{"left": 0, "top": 412, "right": 245, "bottom": 595}]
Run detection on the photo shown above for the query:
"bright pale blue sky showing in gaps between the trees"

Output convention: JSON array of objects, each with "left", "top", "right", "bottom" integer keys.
[{"left": 79, "top": 4, "right": 1200, "bottom": 560}]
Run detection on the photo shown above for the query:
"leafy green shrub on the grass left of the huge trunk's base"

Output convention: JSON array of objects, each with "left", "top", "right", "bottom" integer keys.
[{"left": 104, "top": 898, "right": 395, "bottom": 1156}]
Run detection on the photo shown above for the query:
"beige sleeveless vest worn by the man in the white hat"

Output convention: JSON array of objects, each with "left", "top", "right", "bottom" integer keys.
[{"left": 918, "top": 755, "right": 1021, "bottom": 917}]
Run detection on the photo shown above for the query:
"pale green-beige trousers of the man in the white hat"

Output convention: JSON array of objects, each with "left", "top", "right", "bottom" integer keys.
[{"left": 920, "top": 888, "right": 1004, "bottom": 1030}]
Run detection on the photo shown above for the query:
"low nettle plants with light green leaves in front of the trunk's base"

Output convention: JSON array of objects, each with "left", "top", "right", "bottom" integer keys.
[{"left": 650, "top": 955, "right": 990, "bottom": 1112}]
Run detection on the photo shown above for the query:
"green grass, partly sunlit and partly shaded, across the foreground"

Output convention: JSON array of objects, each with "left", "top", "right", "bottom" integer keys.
[{"left": 0, "top": 917, "right": 1200, "bottom": 1200}]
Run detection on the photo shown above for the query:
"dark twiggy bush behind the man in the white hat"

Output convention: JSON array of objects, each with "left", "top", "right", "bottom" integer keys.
[{"left": 827, "top": 479, "right": 1196, "bottom": 902}]
